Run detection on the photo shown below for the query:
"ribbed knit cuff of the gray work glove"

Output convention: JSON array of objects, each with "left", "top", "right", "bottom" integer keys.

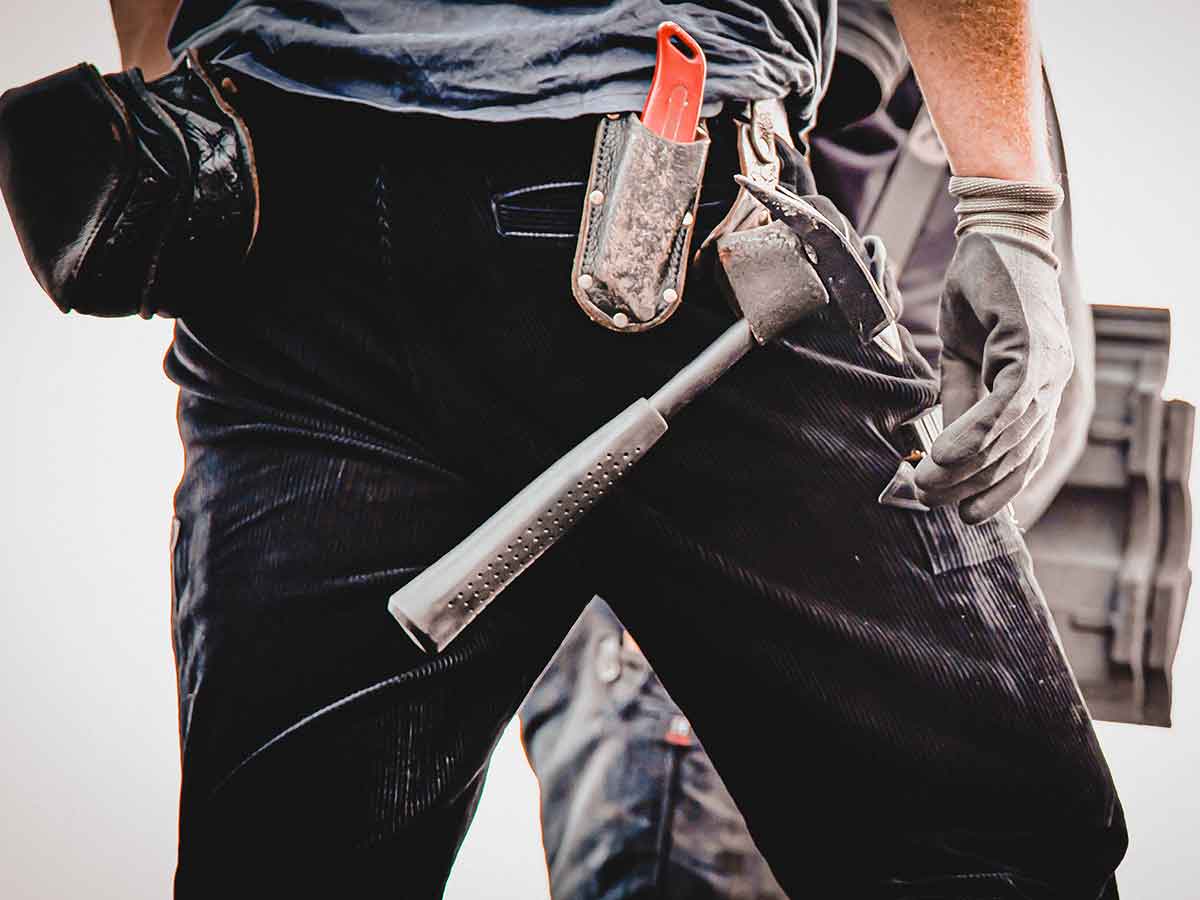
[{"left": 950, "top": 175, "right": 1063, "bottom": 251}]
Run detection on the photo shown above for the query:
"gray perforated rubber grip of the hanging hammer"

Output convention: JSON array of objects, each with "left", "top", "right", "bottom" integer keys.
[{"left": 388, "top": 398, "right": 667, "bottom": 653}]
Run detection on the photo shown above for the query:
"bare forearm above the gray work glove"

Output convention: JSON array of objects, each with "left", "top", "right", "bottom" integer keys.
[{"left": 892, "top": 0, "right": 1055, "bottom": 181}]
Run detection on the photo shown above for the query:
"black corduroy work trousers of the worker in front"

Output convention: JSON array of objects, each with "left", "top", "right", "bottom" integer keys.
[{"left": 166, "top": 84, "right": 1126, "bottom": 900}]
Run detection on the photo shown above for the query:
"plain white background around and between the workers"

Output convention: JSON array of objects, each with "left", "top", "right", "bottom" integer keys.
[{"left": 0, "top": 0, "right": 1200, "bottom": 900}]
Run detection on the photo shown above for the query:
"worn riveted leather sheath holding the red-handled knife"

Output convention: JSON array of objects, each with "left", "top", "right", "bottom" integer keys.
[{"left": 571, "top": 113, "right": 709, "bottom": 331}]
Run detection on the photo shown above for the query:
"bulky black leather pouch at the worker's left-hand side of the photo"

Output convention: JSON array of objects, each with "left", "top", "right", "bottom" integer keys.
[{"left": 0, "top": 55, "right": 258, "bottom": 318}]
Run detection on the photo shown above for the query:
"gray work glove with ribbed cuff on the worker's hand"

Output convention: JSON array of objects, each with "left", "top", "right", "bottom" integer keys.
[{"left": 916, "top": 178, "right": 1074, "bottom": 524}]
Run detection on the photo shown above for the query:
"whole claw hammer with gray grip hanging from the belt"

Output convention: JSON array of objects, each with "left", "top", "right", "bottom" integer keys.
[{"left": 388, "top": 178, "right": 893, "bottom": 653}]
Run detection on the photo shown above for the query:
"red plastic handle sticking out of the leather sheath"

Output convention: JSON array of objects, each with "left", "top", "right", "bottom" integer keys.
[{"left": 642, "top": 22, "right": 708, "bottom": 143}]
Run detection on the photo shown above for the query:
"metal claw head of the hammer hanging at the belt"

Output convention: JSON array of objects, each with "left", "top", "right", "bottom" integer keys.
[{"left": 716, "top": 175, "right": 895, "bottom": 343}]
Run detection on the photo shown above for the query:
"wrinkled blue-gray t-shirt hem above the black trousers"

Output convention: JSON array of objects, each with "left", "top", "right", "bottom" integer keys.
[{"left": 169, "top": 0, "right": 835, "bottom": 126}]
